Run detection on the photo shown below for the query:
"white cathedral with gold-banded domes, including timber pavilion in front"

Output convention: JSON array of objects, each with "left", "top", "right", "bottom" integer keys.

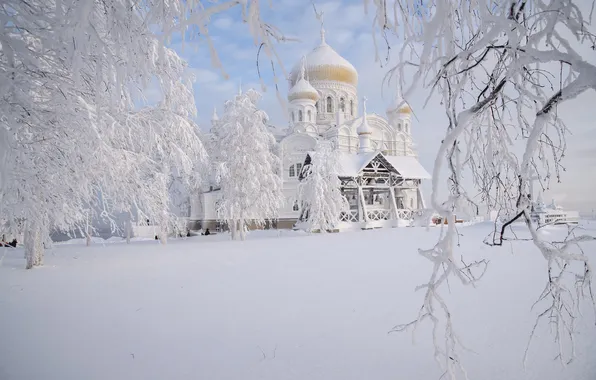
[{"left": 190, "top": 28, "right": 430, "bottom": 230}]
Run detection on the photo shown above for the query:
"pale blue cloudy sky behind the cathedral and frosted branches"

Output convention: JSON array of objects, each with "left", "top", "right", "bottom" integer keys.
[{"left": 159, "top": 0, "right": 596, "bottom": 212}]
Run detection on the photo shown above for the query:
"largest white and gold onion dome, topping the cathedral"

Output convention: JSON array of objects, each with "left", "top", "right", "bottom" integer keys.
[{"left": 290, "top": 29, "right": 358, "bottom": 87}]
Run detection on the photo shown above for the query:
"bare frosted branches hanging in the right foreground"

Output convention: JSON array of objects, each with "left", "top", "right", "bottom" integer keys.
[{"left": 365, "top": 0, "right": 596, "bottom": 379}]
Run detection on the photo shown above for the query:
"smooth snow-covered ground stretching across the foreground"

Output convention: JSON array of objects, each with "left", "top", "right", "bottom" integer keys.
[{"left": 0, "top": 224, "right": 596, "bottom": 380}]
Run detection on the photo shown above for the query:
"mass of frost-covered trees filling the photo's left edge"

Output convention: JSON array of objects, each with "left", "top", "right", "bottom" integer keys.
[{"left": 0, "top": 0, "right": 283, "bottom": 267}]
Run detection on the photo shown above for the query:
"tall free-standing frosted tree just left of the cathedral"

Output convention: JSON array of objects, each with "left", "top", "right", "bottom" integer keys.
[{"left": 213, "top": 90, "right": 284, "bottom": 240}]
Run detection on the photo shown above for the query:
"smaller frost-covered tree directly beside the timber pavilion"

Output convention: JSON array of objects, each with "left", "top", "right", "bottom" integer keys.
[{"left": 298, "top": 141, "right": 349, "bottom": 232}]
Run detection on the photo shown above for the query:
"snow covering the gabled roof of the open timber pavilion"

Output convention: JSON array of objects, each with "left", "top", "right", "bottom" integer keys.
[{"left": 339, "top": 152, "right": 431, "bottom": 179}]
